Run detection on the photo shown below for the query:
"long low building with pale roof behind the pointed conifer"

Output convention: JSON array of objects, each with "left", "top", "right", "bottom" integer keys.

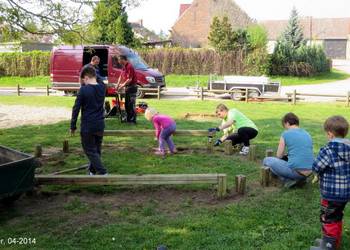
[{"left": 260, "top": 17, "right": 350, "bottom": 59}]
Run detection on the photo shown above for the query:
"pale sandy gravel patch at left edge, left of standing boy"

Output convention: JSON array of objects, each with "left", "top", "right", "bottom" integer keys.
[{"left": 0, "top": 105, "right": 71, "bottom": 129}]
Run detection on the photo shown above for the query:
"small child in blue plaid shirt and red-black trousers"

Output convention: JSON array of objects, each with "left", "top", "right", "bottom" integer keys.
[{"left": 310, "top": 116, "right": 350, "bottom": 250}]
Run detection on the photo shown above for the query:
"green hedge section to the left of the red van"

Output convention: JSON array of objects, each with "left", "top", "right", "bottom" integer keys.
[{"left": 0, "top": 51, "right": 50, "bottom": 76}]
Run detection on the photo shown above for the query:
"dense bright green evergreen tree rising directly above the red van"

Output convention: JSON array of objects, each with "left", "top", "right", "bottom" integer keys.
[{"left": 91, "top": 0, "right": 135, "bottom": 47}]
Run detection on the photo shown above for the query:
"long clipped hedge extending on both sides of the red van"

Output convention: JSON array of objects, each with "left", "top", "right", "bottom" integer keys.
[{"left": 0, "top": 48, "right": 256, "bottom": 76}]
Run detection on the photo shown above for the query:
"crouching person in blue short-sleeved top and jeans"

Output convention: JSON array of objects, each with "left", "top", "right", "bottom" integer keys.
[{"left": 263, "top": 113, "right": 314, "bottom": 187}]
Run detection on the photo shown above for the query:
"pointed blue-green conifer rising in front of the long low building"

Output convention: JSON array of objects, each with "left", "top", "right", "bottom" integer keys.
[{"left": 281, "top": 8, "right": 306, "bottom": 49}]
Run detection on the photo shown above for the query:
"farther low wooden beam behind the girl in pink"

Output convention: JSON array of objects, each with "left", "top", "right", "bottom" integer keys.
[{"left": 104, "top": 129, "right": 209, "bottom": 137}]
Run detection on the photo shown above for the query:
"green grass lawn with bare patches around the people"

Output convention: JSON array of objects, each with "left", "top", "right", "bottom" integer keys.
[{"left": 0, "top": 97, "right": 350, "bottom": 250}]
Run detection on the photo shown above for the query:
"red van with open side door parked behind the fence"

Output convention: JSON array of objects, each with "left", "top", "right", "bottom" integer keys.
[{"left": 50, "top": 45, "right": 165, "bottom": 97}]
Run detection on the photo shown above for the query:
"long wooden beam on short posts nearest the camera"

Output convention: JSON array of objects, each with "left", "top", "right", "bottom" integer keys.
[{"left": 35, "top": 174, "right": 227, "bottom": 197}]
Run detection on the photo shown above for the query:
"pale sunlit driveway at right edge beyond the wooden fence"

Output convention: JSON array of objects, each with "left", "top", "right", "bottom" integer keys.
[{"left": 281, "top": 60, "right": 350, "bottom": 102}]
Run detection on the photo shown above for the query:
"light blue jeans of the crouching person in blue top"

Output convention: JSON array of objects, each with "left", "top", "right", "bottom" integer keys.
[{"left": 263, "top": 157, "right": 306, "bottom": 182}]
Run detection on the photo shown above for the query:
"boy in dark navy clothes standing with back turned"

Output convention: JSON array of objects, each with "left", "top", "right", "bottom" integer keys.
[{"left": 70, "top": 67, "right": 107, "bottom": 175}]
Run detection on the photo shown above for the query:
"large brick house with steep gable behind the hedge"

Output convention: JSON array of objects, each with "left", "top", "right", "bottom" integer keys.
[{"left": 170, "top": 0, "right": 253, "bottom": 48}]
